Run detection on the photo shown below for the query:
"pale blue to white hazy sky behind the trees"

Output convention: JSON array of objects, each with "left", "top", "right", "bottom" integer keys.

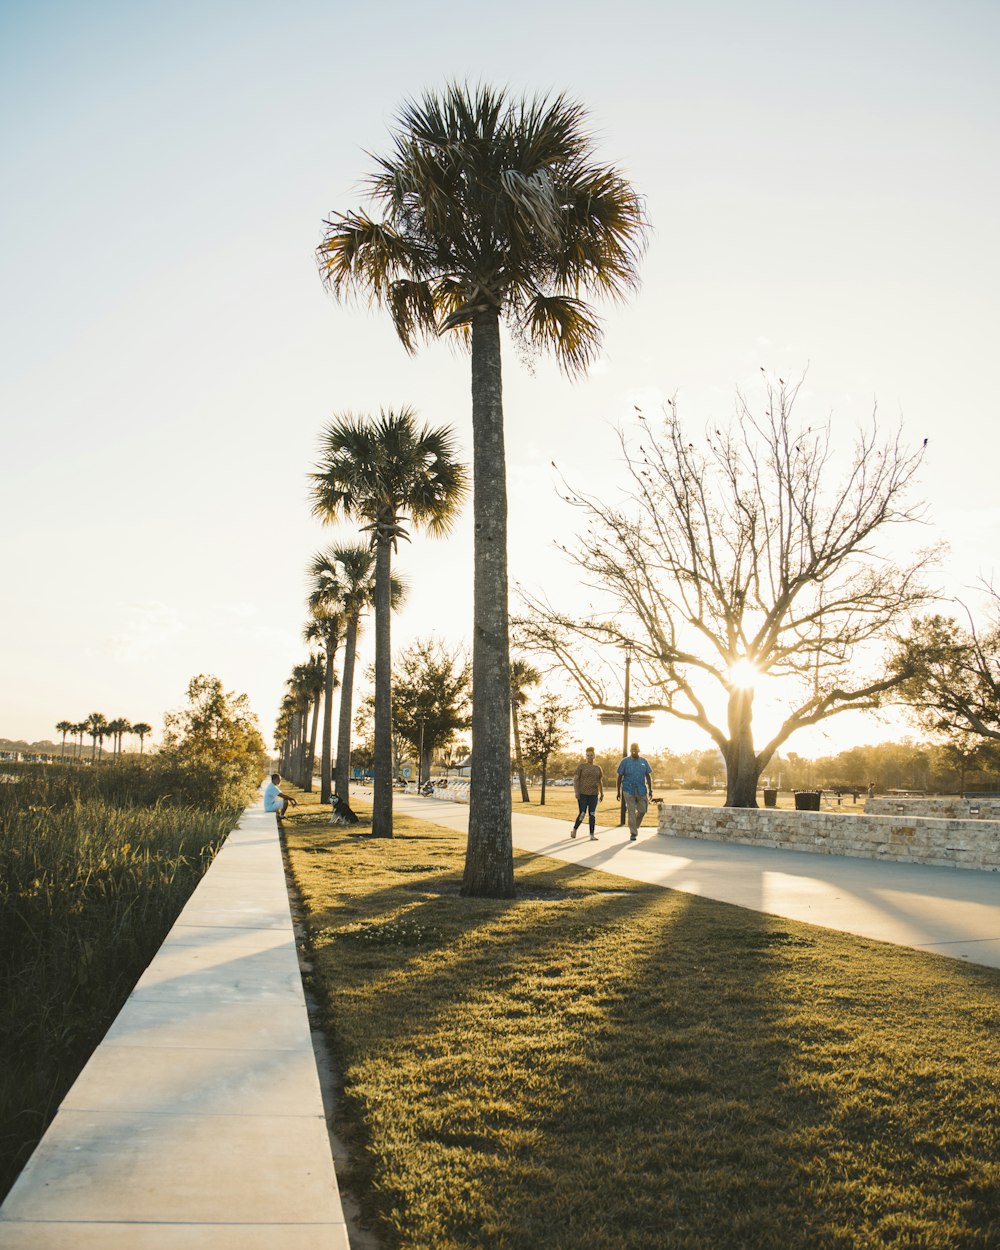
[{"left": 0, "top": 0, "right": 1000, "bottom": 754}]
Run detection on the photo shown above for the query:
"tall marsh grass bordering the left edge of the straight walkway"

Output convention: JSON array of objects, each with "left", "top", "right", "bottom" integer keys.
[{"left": 0, "top": 766, "right": 239, "bottom": 1195}]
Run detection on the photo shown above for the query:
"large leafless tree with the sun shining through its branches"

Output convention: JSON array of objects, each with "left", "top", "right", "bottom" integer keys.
[{"left": 519, "top": 379, "right": 934, "bottom": 808}]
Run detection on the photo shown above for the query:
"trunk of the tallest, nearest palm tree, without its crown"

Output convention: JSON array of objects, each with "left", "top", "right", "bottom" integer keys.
[{"left": 461, "top": 311, "right": 514, "bottom": 899}]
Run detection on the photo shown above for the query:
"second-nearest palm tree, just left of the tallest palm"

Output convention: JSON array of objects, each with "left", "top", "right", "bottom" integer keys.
[{"left": 311, "top": 408, "right": 468, "bottom": 838}]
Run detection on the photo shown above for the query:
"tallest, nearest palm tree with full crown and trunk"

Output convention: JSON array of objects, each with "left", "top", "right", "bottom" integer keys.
[{"left": 318, "top": 84, "right": 646, "bottom": 898}]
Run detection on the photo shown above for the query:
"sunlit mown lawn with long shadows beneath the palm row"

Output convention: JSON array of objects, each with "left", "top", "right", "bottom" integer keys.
[{"left": 286, "top": 796, "right": 1000, "bottom": 1250}]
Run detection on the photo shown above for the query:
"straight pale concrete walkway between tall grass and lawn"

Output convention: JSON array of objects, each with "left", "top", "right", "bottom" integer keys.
[{"left": 0, "top": 806, "right": 348, "bottom": 1250}]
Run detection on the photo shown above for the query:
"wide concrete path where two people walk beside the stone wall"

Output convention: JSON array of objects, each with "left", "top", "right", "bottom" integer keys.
[{"left": 393, "top": 794, "right": 1000, "bottom": 968}]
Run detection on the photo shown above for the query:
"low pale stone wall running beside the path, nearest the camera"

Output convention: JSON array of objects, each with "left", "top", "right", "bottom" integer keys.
[{"left": 659, "top": 803, "right": 1000, "bottom": 873}]
